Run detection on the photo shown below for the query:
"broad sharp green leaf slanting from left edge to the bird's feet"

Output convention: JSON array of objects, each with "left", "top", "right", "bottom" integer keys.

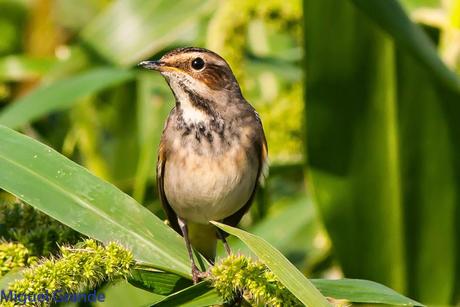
[{"left": 0, "top": 127, "right": 190, "bottom": 278}]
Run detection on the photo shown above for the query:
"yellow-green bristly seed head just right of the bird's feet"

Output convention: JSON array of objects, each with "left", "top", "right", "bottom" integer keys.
[{"left": 209, "top": 255, "right": 302, "bottom": 306}]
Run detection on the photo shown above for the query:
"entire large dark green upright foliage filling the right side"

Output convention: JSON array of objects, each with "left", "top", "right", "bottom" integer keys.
[{"left": 305, "top": 0, "right": 460, "bottom": 304}]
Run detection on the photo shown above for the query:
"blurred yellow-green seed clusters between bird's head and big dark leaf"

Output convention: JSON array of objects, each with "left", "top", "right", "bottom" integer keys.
[{"left": 207, "top": 0, "right": 303, "bottom": 162}]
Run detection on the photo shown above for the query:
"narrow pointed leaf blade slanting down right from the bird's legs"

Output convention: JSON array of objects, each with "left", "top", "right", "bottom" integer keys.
[{"left": 211, "top": 222, "right": 330, "bottom": 307}]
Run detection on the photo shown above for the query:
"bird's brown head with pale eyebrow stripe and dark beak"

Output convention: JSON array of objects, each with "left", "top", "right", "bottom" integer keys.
[{"left": 139, "top": 47, "right": 241, "bottom": 118}]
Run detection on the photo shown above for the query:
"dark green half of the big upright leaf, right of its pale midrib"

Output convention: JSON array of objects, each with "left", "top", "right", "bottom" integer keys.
[{"left": 398, "top": 53, "right": 460, "bottom": 304}]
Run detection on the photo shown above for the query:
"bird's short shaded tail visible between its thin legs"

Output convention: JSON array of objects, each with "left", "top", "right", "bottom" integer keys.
[{"left": 187, "top": 223, "right": 217, "bottom": 263}]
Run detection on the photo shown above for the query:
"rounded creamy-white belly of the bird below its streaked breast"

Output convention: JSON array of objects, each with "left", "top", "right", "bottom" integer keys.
[{"left": 164, "top": 148, "right": 258, "bottom": 224}]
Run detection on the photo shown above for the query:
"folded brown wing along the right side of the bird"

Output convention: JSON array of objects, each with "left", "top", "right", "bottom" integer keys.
[{"left": 223, "top": 122, "right": 268, "bottom": 229}]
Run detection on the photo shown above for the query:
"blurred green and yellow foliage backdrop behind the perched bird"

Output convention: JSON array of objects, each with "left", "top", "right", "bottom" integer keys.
[{"left": 0, "top": 0, "right": 460, "bottom": 305}]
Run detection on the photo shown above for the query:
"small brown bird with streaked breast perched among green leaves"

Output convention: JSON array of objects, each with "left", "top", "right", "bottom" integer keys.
[{"left": 139, "top": 47, "right": 267, "bottom": 283}]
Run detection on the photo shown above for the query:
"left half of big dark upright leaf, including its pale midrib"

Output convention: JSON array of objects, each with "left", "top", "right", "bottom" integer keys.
[{"left": 305, "top": 0, "right": 406, "bottom": 292}]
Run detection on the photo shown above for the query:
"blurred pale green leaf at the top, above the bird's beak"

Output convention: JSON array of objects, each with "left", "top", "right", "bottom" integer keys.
[{"left": 82, "top": 0, "right": 217, "bottom": 66}]
